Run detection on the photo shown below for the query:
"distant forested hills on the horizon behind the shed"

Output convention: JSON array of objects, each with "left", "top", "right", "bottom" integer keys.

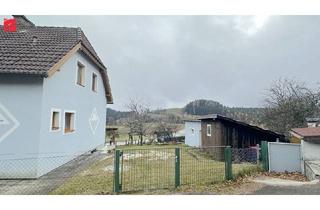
[{"left": 107, "top": 99, "right": 263, "bottom": 125}]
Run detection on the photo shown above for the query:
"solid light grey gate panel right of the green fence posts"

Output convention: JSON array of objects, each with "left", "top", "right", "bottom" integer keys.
[{"left": 268, "top": 142, "right": 301, "bottom": 172}]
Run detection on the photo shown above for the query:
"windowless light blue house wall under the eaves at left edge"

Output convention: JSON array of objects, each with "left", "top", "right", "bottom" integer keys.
[{"left": 0, "top": 74, "right": 43, "bottom": 178}]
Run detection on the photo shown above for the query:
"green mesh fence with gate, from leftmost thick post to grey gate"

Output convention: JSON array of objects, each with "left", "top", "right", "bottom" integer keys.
[{"left": 114, "top": 147, "right": 260, "bottom": 193}]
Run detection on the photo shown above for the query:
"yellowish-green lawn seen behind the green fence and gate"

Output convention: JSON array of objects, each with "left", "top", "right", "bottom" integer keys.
[{"left": 52, "top": 144, "right": 258, "bottom": 194}]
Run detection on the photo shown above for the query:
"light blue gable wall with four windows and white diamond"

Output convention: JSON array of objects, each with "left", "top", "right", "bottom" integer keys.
[{"left": 38, "top": 52, "right": 106, "bottom": 176}]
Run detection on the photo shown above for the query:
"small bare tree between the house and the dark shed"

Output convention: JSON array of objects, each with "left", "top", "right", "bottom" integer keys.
[{"left": 126, "top": 98, "right": 150, "bottom": 145}]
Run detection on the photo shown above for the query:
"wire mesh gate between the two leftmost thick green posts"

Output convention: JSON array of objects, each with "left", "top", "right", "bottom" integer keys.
[{"left": 120, "top": 148, "right": 175, "bottom": 192}]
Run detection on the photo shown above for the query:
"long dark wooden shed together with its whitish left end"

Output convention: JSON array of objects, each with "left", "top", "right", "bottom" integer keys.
[{"left": 185, "top": 115, "right": 285, "bottom": 148}]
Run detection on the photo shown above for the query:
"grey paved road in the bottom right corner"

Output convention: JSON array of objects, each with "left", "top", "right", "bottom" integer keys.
[{"left": 252, "top": 183, "right": 320, "bottom": 195}]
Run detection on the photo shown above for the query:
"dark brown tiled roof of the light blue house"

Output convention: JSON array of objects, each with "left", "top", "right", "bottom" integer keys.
[{"left": 0, "top": 15, "right": 113, "bottom": 103}]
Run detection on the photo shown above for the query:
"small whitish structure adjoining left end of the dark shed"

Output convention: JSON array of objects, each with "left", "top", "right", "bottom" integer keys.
[{"left": 185, "top": 120, "right": 201, "bottom": 147}]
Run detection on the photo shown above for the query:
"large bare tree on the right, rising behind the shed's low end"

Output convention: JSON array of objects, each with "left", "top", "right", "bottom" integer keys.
[{"left": 263, "top": 79, "right": 320, "bottom": 135}]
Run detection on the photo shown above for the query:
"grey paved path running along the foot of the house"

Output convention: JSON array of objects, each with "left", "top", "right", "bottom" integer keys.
[{"left": 0, "top": 151, "right": 106, "bottom": 195}]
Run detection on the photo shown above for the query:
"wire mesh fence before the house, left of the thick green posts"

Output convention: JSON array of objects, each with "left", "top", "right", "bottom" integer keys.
[{"left": 0, "top": 152, "right": 113, "bottom": 195}]
